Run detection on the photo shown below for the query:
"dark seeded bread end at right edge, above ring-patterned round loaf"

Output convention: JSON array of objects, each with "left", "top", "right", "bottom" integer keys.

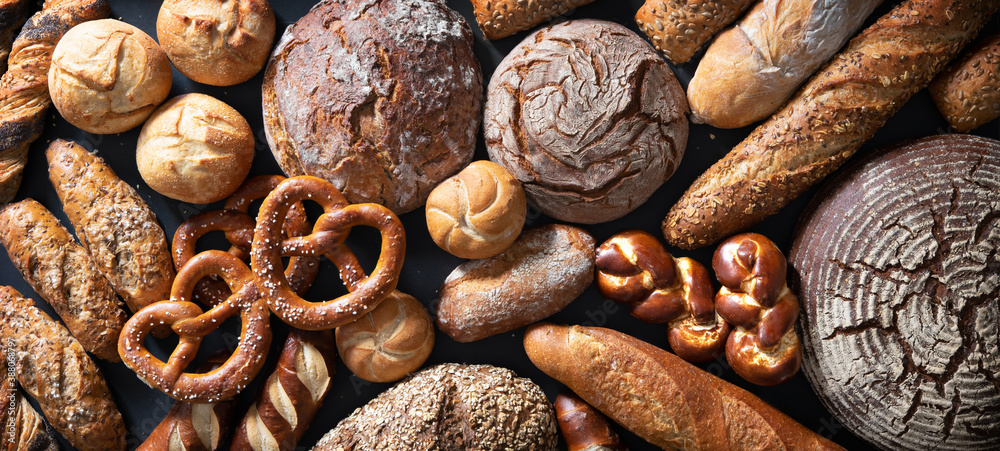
[{"left": 928, "top": 33, "right": 1000, "bottom": 133}]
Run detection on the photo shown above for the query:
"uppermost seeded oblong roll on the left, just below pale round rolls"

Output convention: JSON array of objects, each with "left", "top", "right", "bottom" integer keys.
[{"left": 45, "top": 139, "right": 174, "bottom": 312}]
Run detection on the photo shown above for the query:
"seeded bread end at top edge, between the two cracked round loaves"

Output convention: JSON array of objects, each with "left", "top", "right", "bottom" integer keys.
[{"left": 472, "top": 0, "right": 594, "bottom": 40}]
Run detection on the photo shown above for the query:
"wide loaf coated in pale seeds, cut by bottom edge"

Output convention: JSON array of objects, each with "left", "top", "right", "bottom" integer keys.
[{"left": 313, "top": 363, "right": 559, "bottom": 451}]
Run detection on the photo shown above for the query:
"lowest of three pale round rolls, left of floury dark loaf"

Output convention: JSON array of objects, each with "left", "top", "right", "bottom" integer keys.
[{"left": 135, "top": 94, "right": 254, "bottom": 204}]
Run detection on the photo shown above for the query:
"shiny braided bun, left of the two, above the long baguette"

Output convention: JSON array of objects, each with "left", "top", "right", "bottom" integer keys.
[{"left": 595, "top": 230, "right": 730, "bottom": 362}]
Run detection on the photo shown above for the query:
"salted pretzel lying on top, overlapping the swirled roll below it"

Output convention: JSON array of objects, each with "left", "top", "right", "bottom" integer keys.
[{"left": 250, "top": 176, "right": 406, "bottom": 330}]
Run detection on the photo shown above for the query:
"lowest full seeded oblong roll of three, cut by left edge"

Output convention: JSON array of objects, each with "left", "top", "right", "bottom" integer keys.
[{"left": 0, "top": 286, "right": 125, "bottom": 450}]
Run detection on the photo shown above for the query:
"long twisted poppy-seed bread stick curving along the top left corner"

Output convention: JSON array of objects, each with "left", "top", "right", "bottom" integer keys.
[{"left": 0, "top": 0, "right": 111, "bottom": 203}]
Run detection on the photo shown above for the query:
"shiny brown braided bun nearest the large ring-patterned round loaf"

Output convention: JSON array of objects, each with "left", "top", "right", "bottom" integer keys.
[{"left": 712, "top": 233, "right": 802, "bottom": 385}]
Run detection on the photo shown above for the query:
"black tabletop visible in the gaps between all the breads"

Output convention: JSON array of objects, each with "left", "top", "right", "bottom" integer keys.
[{"left": 0, "top": 0, "right": 1000, "bottom": 450}]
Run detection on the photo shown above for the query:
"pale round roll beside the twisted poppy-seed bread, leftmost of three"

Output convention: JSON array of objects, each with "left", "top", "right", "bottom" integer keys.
[{"left": 49, "top": 19, "right": 173, "bottom": 134}]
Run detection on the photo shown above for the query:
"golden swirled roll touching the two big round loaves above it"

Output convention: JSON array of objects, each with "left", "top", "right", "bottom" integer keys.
[{"left": 426, "top": 160, "right": 527, "bottom": 258}]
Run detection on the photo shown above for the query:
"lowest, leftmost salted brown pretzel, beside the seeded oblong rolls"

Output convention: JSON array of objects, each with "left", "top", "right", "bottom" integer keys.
[{"left": 118, "top": 250, "right": 271, "bottom": 402}]
